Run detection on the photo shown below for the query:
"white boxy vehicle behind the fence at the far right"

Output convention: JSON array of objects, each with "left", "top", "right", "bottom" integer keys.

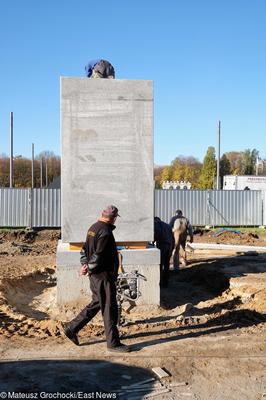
[{"left": 223, "top": 175, "right": 266, "bottom": 190}]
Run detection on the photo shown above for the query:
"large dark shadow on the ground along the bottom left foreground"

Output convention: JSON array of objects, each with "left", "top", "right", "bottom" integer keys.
[{"left": 0, "top": 360, "right": 154, "bottom": 398}]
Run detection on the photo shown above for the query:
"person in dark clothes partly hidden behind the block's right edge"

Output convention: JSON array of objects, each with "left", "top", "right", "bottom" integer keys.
[{"left": 154, "top": 217, "right": 174, "bottom": 287}]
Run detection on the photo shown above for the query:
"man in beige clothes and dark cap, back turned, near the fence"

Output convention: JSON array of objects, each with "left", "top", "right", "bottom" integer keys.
[{"left": 170, "top": 210, "right": 193, "bottom": 270}]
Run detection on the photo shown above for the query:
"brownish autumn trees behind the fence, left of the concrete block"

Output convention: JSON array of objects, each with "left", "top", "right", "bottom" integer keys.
[{"left": 0, "top": 151, "right": 61, "bottom": 188}]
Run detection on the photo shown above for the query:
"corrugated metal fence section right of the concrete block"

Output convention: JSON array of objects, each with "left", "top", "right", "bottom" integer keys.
[{"left": 155, "top": 190, "right": 266, "bottom": 226}]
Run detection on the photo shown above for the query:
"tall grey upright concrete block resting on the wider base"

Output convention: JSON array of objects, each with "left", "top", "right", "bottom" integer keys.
[{"left": 61, "top": 78, "right": 154, "bottom": 242}]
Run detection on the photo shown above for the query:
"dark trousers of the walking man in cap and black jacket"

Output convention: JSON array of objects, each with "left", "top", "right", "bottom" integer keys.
[{"left": 68, "top": 271, "right": 120, "bottom": 347}]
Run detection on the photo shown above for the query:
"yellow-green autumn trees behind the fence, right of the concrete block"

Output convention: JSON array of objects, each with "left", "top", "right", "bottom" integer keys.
[{"left": 154, "top": 146, "right": 259, "bottom": 189}]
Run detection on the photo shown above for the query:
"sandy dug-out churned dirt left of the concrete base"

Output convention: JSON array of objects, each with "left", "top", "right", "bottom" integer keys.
[{"left": 0, "top": 267, "right": 60, "bottom": 338}]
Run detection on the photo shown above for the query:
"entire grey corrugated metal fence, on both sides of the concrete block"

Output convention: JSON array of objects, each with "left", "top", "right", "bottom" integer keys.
[{"left": 0, "top": 188, "right": 266, "bottom": 228}]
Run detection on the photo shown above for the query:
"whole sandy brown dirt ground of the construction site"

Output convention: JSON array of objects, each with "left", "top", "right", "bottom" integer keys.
[{"left": 0, "top": 230, "right": 266, "bottom": 400}]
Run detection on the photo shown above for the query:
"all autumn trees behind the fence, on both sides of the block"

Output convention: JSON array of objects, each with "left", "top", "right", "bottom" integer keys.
[{"left": 0, "top": 146, "right": 259, "bottom": 189}]
